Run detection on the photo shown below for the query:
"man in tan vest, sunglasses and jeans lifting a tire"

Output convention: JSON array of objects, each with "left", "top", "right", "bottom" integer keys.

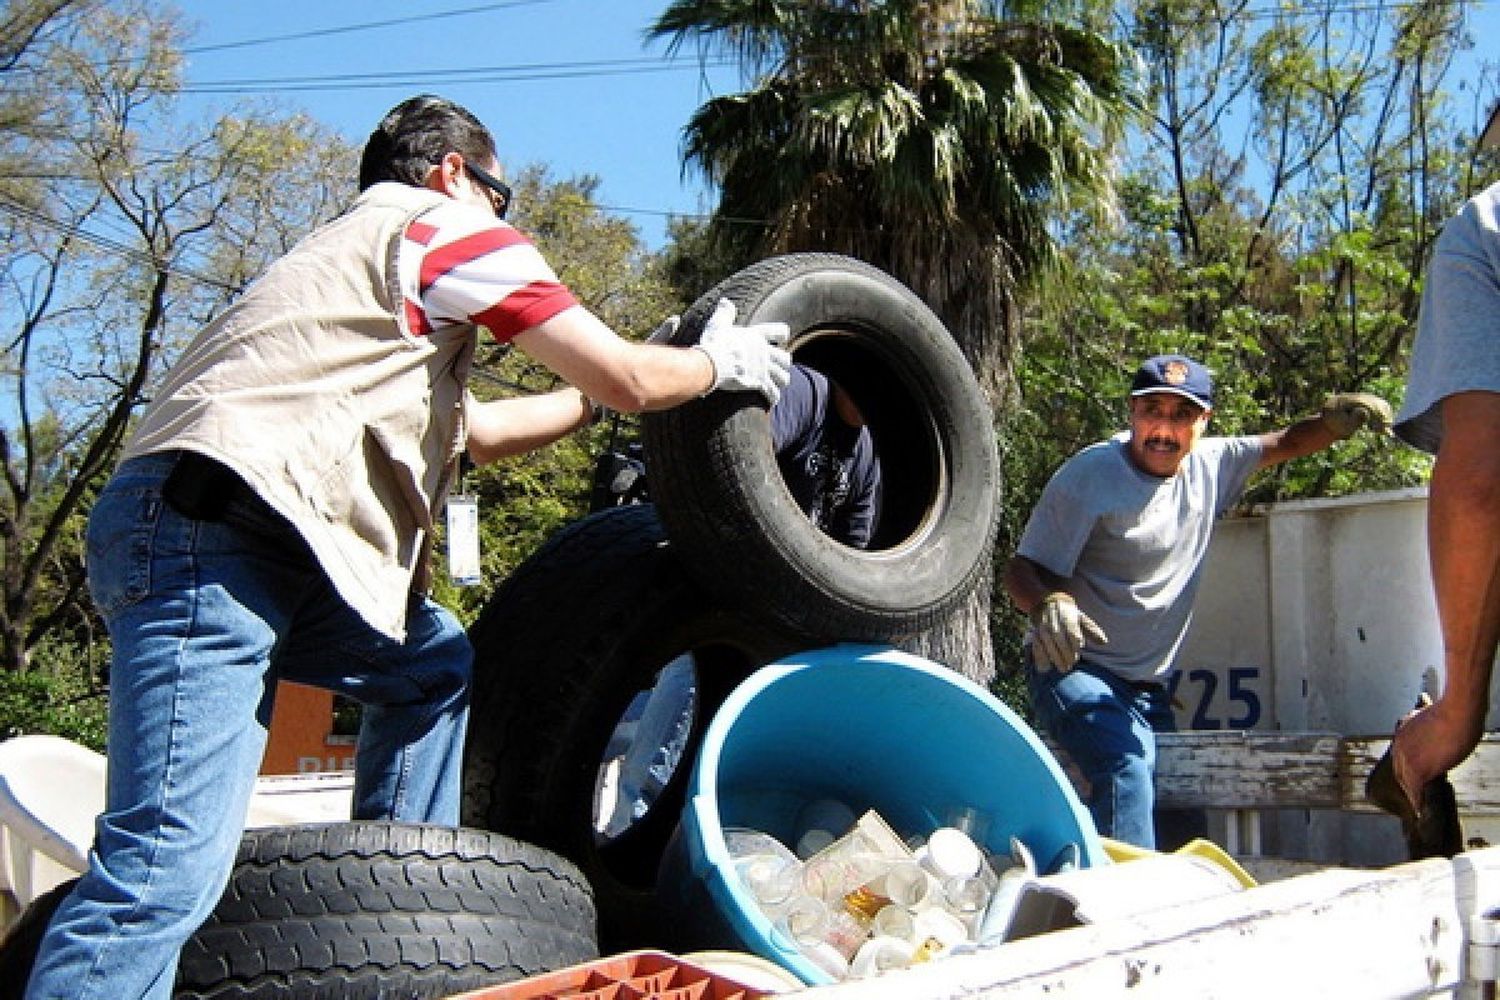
[{"left": 26, "top": 96, "right": 791, "bottom": 1000}]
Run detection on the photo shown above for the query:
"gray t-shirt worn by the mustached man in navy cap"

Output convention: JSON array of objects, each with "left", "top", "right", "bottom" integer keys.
[{"left": 1017, "top": 433, "right": 1262, "bottom": 681}]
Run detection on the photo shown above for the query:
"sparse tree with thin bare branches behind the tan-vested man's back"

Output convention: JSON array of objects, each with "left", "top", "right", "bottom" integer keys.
[{"left": 0, "top": 1, "right": 354, "bottom": 739}]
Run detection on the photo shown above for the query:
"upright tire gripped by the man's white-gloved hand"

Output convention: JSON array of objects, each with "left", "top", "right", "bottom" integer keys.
[{"left": 644, "top": 253, "right": 999, "bottom": 642}]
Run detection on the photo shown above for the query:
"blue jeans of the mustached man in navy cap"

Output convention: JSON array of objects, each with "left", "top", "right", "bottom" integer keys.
[{"left": 1026, "top": 661, "right": 1203, "bottom": 849}]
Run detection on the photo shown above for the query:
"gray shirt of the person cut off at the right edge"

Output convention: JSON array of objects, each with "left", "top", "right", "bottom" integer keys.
[{"left": 1395, "top": 183, "right": 1500, "bottom": 453}]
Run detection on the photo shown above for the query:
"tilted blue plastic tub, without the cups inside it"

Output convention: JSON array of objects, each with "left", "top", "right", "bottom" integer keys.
[{"left": 659, "top": 645, "right": 1109, "bottom": 985}]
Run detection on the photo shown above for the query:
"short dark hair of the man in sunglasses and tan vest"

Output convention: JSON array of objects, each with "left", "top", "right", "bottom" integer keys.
[{"left": 360, "top": 94, "right": 495, "bottom": 190}]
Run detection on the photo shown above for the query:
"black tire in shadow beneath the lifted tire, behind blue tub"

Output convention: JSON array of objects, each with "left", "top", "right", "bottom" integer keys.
[{"left": 464, "top": 504, "right": 806, "bottom": 954}]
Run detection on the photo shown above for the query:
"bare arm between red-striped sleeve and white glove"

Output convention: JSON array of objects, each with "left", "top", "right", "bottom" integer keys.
[{"left": 515, "top": 306, "right": 714, "bottom": 414}]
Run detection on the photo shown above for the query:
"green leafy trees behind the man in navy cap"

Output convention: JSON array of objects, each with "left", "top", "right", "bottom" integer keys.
[{"left": 998, "top": 0, "right": 1497, "bottom": 671}]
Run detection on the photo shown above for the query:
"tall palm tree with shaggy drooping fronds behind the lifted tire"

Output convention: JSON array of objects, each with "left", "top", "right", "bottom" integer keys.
[{"left": 648, "top": 0, "right": 1133, "bottom": 679}]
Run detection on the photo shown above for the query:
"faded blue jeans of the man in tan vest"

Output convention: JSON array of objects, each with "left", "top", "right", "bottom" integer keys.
[{"left": 26, "top": 453, "right": 473, "bottom": 1000}]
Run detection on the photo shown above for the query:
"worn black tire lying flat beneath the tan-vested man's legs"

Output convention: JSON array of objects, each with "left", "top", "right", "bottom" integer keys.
[{"left": 0, "top": 823, "right": 599, "bottom": 1000}]
